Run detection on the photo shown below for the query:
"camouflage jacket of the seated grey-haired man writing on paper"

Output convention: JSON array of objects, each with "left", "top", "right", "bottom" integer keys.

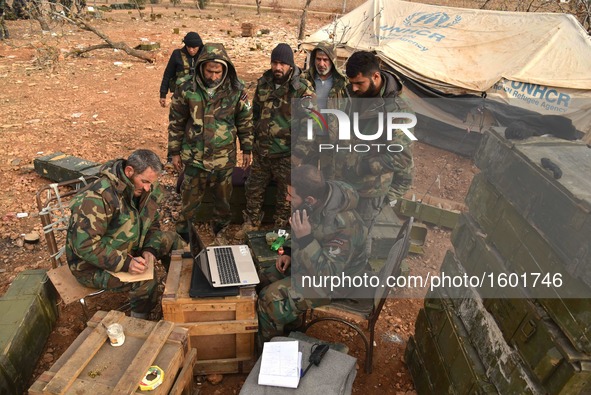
[{"left": 66, "top": 159, "right": 162, "bottom": 272}]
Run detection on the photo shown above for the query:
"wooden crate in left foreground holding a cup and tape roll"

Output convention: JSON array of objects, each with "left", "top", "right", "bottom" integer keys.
[{"left": 29, "top": 311, "right": 196, "bottom": 395}]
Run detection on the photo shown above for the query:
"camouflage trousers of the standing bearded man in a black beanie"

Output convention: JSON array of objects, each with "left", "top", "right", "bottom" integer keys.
[{"left": 244, "top": 151, "right": 291, "bottom": 226}]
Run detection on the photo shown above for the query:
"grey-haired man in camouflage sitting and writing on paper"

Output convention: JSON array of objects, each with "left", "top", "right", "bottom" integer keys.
[{"left": 66, "top": 150, "right": 183, "bottom": 318}]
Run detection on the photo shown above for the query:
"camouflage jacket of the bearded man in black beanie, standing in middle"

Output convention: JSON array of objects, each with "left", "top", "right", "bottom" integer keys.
[{"left": 253, "top": 66, "right": 316, "bottom": 158}]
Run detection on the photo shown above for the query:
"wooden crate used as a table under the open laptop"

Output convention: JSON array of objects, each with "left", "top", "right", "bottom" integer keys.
[{"left": 162, "top": 251, "right": 258, "bottom": 374}]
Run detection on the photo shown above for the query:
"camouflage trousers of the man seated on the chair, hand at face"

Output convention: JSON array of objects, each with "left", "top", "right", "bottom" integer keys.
[{"left": 257, "top": 265, "right": 330, "bottom": 346}]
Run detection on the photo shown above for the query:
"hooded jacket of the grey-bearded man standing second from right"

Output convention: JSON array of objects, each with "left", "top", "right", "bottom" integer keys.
[{"left": 304, "top": 43, "right": 349, "bottom": 111}]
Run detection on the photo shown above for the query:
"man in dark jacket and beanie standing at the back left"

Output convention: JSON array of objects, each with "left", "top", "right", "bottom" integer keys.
[{"left": 160, "top": 32, "right": 203, "bottom": 107}]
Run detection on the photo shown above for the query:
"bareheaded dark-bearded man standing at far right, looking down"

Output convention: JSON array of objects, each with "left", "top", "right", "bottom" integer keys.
[{"left": 336, "top": 51, "right": 413, "bottom": 241}]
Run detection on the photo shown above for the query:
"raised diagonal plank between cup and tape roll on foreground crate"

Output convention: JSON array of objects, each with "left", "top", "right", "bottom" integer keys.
[{"left": 113, "top": 321, "right": 174, "bottom": 395}]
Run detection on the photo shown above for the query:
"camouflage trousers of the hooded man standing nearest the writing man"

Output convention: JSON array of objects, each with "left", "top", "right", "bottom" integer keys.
[{"left": 176, "top": 166, "right": 234, "bottom": 234}]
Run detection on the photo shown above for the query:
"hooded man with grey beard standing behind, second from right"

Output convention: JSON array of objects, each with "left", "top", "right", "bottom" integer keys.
[{"left": 304, "top": 42, "right": 349, "bottom": 179}]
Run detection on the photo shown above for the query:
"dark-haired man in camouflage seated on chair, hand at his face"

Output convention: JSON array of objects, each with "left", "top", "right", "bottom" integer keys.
[{"left": 257, "top": 165, "right": 368, "bottom": 345}]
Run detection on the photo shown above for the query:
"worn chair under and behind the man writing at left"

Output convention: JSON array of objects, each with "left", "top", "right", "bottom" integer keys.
[{"left": 36, "top": 176, "right": 128, "bottom": 321}]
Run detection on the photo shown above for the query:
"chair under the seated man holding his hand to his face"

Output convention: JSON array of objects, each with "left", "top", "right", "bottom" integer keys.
[{"left": 304, "top": 217, "right": 414, "bottom": 373}]
